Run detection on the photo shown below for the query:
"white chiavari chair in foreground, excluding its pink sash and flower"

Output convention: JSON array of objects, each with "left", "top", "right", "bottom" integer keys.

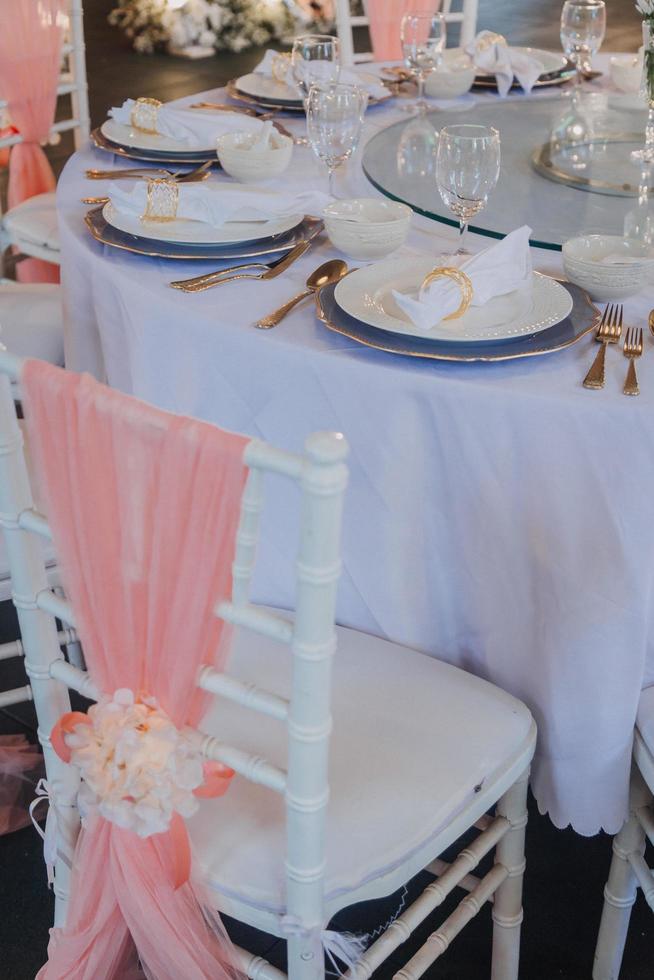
[{"left": 0, "top": 353, "right": 536, "bottom": 980}]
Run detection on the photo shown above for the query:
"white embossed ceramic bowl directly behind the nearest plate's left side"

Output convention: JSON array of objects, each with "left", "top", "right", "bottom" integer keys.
[{"left": 323, "top": 197, "right": 413, "bottom": 261}]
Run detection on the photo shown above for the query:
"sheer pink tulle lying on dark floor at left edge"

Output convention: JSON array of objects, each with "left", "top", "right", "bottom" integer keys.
[{"left": 0, "top": 735, "right": 43, "bottom": 834}]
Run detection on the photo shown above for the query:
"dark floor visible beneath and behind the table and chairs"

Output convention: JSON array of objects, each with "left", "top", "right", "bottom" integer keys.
[{"left": 0, "top": 0, "right": 654, "bottom": 980}]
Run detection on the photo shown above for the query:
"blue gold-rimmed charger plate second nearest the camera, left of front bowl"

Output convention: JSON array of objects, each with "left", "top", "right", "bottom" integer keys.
[{"left": 84, "top": 206, "right": 324, "bottom": 261}]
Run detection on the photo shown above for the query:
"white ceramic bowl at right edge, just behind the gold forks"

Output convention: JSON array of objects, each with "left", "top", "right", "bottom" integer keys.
[{"left": 563, "top": 235, "right": 654, "bottom": 303}]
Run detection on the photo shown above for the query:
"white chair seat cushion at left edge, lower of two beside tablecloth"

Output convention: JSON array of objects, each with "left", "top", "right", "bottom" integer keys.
[{"left": 0, "top": 282, "right": 64, "bottom": 366}]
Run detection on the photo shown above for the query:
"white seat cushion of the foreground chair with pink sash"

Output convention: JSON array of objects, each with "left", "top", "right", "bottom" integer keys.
[{"left": 188, "top": 628, "right": 535, "bottom": 928}]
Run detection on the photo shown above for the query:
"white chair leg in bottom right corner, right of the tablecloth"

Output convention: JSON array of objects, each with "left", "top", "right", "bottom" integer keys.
[{"left": 593, "top": 765, "right": 651, "bottom": 980}]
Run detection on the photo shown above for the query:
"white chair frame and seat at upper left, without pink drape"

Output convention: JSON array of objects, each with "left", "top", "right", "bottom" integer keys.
[{"left": 0, "top": 0, "right": 90, "bottom": 265}]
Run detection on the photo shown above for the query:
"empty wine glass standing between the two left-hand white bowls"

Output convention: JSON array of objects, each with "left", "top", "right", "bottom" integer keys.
[{"left": 306, "top": 82, "right": 368, "bottom": 197}]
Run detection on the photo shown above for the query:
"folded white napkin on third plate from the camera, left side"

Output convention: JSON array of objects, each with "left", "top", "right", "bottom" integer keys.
[{"left": 109, "top": 99, "right": 263, "bottom": 149}]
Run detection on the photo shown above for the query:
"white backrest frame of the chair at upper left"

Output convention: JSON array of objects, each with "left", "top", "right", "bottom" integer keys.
[{"left": 0, "top": 0, "right": 90, "bottom": 157}]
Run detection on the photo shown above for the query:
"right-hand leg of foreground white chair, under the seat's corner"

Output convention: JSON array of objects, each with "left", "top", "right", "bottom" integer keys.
[{"left": 491, "top": 769, "right": 529, "bottom": 980}]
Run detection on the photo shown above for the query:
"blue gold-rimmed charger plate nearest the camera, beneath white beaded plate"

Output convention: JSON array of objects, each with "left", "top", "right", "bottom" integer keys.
[{"left": 316, "top": 282, "right": 600, "bottom": 363}]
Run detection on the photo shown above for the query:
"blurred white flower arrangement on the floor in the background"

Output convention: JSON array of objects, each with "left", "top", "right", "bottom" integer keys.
[{"left": 109, "top": 0, "right": 333, "bottom": 54}]
